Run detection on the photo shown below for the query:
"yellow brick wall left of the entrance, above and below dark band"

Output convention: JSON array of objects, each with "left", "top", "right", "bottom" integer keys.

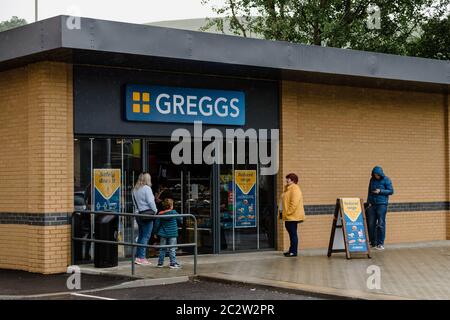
[{"left": 0, "top": 62, "right": 73, "bottom": 273}]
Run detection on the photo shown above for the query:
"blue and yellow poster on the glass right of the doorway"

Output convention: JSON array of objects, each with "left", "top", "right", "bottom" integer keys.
[{"left": 234, "top": 170, "right": 257, "bottom": 228}]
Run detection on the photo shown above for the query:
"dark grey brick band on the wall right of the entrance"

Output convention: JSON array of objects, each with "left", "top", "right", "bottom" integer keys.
[{"left": 305, "top": 201, "right": 450, "bottom": 216}]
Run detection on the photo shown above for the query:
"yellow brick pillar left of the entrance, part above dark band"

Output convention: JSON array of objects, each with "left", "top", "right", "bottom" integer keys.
[{"left": 28, "top": 63, "right": 73, "bottom": 213}]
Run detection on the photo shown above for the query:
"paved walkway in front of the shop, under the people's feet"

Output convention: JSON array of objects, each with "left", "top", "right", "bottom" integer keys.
[{"left": 79, "top": 241, "right": 450, "bottom": 299}]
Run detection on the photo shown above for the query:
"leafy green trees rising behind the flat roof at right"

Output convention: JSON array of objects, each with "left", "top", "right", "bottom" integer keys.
[{"left": 203, "top": 0, "right": 450, "bottom": 57}]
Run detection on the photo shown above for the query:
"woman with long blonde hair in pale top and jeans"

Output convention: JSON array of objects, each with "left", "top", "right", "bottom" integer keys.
[{"left": 133, "top": 173, "right": 158, "bottom": 265}]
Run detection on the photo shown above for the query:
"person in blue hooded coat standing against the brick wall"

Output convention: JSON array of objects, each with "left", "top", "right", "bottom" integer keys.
[{"left": 366, "top": 166, "right": 394, "bottom": 250}]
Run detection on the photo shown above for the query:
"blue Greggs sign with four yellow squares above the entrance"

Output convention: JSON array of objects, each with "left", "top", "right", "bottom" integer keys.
[{"left": 126, "top": 85, "right": 245, "bottom": 126}]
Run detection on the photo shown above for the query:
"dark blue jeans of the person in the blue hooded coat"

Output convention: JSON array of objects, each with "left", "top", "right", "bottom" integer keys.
[{"left": 367, "top": 204, "right": 387, "bottom": 246}]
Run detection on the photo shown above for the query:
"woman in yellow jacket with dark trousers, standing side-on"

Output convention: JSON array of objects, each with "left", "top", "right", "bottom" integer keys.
[{"left": 279, "top": 173, "right": 305, "bottom": 257}]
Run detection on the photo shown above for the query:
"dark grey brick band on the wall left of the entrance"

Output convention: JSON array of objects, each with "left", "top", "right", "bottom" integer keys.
[{"left": 0, "top": 212, "right": 71, "bottom": 226}]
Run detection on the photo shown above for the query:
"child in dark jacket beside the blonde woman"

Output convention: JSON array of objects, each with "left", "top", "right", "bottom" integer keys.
[{"left": 155, "top": 198, "right": 181, "bottom": 269}]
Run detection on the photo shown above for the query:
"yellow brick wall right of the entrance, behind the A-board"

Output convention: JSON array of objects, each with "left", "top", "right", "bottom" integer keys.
[{"left": 278, "top": 81, "right": 449, "bottom": 249}]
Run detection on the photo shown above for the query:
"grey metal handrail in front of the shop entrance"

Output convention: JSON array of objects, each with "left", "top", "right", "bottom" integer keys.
[{"left": 71, "top": 210, "right": 198, "bottom": 275}]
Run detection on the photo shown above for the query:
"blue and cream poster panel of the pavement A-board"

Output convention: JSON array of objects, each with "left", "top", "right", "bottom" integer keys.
[{"left": 342, "top": 198, "right": 368, "bottom": 252}]
